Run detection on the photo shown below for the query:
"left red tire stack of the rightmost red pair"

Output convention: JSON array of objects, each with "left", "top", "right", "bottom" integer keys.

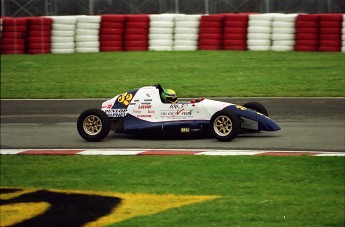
[{"left": 295, "top": 14, "right": 320, "bottom": 51}]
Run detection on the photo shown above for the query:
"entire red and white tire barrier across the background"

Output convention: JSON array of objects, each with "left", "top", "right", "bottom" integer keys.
[{"left": 0, "top": 13, "right": 345, "bottom": 54}]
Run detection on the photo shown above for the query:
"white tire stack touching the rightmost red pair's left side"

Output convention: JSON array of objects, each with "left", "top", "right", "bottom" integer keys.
[{"left": 271, "top": 14, "right": 297, "bottom": 51}]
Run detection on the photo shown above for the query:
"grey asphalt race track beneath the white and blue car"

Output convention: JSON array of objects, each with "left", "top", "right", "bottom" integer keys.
[{"left": 1, "top": 98, "right": 345, "bottom": 152}]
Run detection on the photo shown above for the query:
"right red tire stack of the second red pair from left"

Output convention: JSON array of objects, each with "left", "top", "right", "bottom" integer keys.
[{"left": 124, "top": 15, "right": 150, "bottom": 51}]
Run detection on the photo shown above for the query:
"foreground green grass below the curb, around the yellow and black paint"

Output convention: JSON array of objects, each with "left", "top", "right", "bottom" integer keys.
[{"left": 0, "top": 155, "right": 345, "bottom": 226}]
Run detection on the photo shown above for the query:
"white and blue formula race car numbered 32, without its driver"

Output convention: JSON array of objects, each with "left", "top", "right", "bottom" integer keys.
[{"left": 77, "top": 84, "right": 280, "bottom": 141}]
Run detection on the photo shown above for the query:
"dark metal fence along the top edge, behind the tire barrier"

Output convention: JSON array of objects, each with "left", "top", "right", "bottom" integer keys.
[{"left": 1, "top": 0, "right": 345, "bottom": 17}]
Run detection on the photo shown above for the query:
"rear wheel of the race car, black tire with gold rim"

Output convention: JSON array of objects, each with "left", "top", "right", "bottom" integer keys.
[{"left": 77, "top": 109, "right": 110, "bottom": 142}]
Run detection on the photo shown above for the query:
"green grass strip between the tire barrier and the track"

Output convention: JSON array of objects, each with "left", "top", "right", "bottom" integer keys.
[{"left": 1, "top": 51, "right": 345, "bottom": 98}]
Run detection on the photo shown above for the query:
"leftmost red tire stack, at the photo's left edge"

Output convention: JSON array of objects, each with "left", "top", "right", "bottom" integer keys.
[{"left": 1, "top": 18, "right": 27, "bottom": 54}]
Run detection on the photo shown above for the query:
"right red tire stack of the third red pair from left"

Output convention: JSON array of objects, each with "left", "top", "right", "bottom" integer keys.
[{"left": 223, "top": 14, "right": 249, "bottom": 50}]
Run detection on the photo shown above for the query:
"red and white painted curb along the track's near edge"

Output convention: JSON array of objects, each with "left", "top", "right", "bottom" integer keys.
[{"left": 0, "top": 149, "right": 345, "bottom": 157}]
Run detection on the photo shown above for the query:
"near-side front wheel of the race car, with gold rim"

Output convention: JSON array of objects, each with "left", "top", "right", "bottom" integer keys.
[{"left": 211, "top": 110, "right": 241, "bottom": 142}]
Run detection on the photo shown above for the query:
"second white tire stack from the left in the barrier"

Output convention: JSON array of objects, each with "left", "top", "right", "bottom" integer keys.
[{"left": 75, "top": 16, "right": 101, "bottom": 53}]
